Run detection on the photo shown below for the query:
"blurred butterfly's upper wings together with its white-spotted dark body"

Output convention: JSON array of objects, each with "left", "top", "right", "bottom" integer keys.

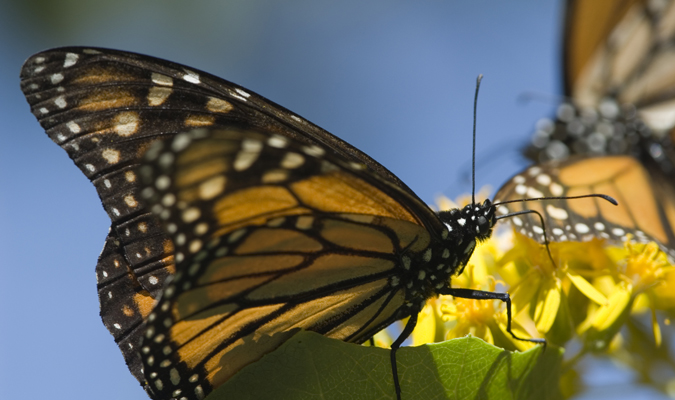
[{"left": 525, "top": 0, "right": 675, "bottom": 180}]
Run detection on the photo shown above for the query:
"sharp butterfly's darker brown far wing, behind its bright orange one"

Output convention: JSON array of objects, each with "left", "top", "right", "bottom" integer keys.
[{"left": 21, "top": 47, "right": 439, "bottom": 383}]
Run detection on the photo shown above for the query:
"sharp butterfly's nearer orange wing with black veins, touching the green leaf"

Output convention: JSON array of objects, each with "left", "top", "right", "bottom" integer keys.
[{"left": 137, "top": 129, "right": 449, "bottom": 398}]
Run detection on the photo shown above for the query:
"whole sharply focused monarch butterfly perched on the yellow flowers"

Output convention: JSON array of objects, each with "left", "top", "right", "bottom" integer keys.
[{"left": 21, "top": 47, "right": 572, "bottom": 399}]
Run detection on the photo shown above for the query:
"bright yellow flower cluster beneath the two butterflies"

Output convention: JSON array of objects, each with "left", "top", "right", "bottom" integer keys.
[{"left": 412, "top": 195, "right": 675, "bottom": 353}]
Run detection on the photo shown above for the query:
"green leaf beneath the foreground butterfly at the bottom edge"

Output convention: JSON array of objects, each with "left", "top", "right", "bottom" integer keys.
[{"left": 207, "top": 332, "right": 562, "bottom": 400}]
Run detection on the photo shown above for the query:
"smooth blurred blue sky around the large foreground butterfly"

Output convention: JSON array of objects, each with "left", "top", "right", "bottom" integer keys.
[{"left": 0, "top": 0, "right": 664, "bottom": 400}]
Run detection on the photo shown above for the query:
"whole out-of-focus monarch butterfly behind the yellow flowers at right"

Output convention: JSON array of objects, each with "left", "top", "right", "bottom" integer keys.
[{"left": 495, "top": 0, "right": 675, "bottom": 258}]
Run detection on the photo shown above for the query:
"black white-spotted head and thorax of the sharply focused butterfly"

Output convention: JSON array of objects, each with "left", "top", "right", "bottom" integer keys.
[{"left": 392, "top": 200, "right": 495, "bottom": 310}]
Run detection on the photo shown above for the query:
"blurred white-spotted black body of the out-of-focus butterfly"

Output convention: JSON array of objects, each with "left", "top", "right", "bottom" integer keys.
[{"left": 525, "top": 97, "right": 675, "bottom": 176}]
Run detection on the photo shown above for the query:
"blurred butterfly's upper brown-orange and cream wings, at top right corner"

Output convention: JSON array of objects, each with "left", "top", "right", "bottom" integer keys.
[{"left": 563, "top": 0, "right": 675, "bottom": 114}]
